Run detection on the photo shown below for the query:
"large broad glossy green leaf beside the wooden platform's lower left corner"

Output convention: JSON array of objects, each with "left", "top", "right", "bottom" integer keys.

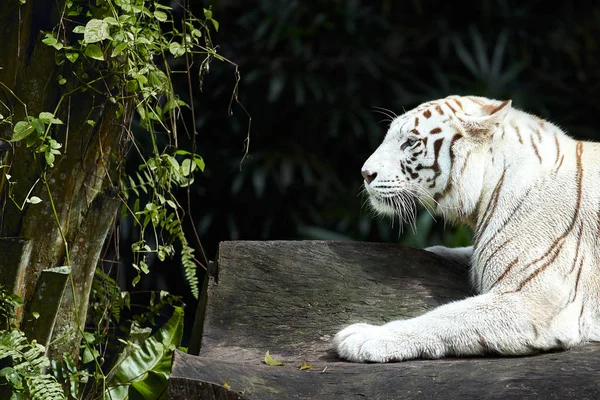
[{"left": 106, "top": 307, "right": 184, "bottom": 400}]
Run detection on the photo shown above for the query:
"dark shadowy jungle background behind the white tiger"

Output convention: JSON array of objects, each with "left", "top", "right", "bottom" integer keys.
[{"left": 120, "top": 0, "right": 600, "bottom": 344}]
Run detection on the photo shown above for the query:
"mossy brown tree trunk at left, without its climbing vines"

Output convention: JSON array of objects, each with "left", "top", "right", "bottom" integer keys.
[{"left": 0, "top": 0, "right": 130, "bottom": 358}]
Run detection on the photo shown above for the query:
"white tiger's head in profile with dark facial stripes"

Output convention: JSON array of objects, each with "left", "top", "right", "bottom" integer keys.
[{"left": 362, "top": 96, "right": 511, "bottom": 222}]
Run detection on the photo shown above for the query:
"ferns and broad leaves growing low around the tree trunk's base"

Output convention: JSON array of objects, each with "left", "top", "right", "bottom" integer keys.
[{"left": 0, "top": 282, "right": 184, "bottom": 400}]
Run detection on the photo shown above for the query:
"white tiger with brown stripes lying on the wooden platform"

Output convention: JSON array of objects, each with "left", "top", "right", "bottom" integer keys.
[{"left": 333, "top": 96, "right": 600, "bottom": 362}]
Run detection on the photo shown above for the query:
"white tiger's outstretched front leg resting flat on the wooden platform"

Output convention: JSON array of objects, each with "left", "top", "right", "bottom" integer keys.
[{"left": 333, "top": 293, "right": 579, "bottom": 362}]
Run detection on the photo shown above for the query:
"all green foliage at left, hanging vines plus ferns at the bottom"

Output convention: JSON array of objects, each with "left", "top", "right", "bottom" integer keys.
[{"left": 0, "top": 0, "right": 239, "bottom": 399}]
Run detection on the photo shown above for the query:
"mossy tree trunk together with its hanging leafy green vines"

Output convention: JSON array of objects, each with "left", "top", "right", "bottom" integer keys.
[{"left": 0, "top": 0, "right": 239, "bottom": 396}]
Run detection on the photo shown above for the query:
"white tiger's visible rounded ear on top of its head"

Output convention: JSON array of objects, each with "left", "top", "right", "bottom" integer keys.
[{"left": 460, "top": 99, "right": 512, "bottom": 137}]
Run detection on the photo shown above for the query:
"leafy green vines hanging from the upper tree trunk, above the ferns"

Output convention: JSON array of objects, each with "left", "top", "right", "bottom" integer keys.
[{"left": 2, "top": 0, "right": 235, "bottom": 298}]
